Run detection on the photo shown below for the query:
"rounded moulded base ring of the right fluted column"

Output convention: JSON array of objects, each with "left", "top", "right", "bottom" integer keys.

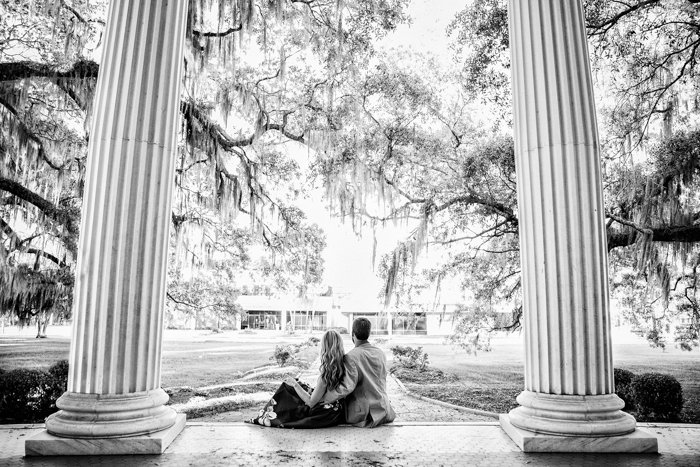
[{"left": 508, "top": 391, "right": 637, "bottom": 437}]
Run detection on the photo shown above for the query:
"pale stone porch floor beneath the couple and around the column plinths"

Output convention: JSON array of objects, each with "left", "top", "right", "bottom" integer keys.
[{"left": 0, "top": 422, "right": 700, "bottom": 467}]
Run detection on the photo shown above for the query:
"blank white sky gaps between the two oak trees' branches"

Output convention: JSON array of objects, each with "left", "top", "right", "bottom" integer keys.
[{"left": 306, "top": 0, "right": 467, "bottom": 309}]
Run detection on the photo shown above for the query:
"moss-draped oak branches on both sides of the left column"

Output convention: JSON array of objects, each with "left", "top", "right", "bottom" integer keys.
[{"left": 0, "top": 0, "right": 406, "bottom": 330}]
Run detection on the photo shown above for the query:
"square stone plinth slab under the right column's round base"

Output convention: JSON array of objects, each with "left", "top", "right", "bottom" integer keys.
[{"left": 500, "top": 415, "right": 659, "bottom": 454}]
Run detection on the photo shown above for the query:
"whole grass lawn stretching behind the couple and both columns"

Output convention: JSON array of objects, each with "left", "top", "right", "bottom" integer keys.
[{"left": 0, "top": 331, "right": 700, "bottom": 423}]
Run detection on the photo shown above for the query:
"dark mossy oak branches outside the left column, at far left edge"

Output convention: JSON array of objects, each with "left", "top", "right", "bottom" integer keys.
[{"left": 0, "top": 2, "right": 99, "bottom": 337}]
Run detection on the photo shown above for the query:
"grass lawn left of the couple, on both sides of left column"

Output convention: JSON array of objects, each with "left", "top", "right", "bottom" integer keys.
[{"left": 0, "top": 329, "right": 319, "bottom": 426}]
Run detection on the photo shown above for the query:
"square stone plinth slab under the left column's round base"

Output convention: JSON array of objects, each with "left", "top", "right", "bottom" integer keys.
[{"left": 24, "top": 414, "right": 186, "bottom": 456}]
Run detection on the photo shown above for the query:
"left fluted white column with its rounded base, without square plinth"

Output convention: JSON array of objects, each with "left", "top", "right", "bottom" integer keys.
[{"left": 46, "top": 0, "right": 188, "bottom": 438}]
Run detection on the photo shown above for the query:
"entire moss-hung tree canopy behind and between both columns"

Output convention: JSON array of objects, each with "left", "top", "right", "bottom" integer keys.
[{"left": 0, "top": 0, "right": 700, "bottom": 349}]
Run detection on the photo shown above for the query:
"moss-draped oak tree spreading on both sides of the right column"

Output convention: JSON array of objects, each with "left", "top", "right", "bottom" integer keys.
[{"left": 298, "top": 0, "right": 700, "bottom": 351}]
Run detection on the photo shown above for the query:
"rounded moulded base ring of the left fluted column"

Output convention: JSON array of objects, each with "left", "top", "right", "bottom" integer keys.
[{"left": 46, "top": 388, "right": 177, "bottom": 438}]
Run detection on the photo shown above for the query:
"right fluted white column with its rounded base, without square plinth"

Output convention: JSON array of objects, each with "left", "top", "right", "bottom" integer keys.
[{"left": 509, "top": 0, "right": 635, "bottom": 437}]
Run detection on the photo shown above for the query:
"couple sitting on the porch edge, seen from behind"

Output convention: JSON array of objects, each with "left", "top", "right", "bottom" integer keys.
[{"left": 246, "top": 318, "right": 395, "bottom": 428}]
